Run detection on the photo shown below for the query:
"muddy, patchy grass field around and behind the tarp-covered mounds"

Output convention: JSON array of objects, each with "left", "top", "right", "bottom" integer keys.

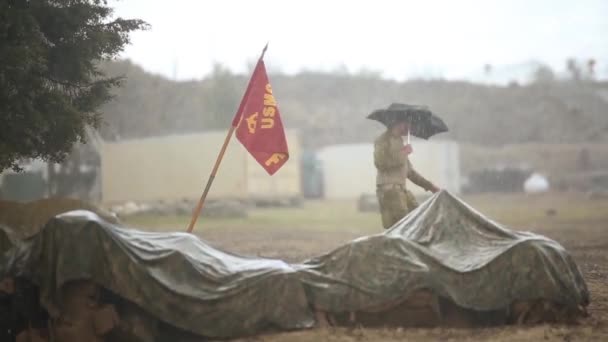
[{"left": 127, "top": 193, "right": 608, "bottom": 342}]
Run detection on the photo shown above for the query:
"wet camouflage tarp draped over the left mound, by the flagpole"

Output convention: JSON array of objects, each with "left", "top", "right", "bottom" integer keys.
[{"left": 7, "top": 211, "right": 314, "bottom": 337}]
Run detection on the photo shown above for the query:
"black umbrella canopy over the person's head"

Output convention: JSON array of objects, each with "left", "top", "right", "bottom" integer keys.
[{"left": 367, "top": 103, "right": 448, "bottom": 139}]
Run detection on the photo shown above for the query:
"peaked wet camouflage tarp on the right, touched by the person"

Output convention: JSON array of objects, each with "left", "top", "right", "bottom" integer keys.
[{"left": 299, "top": 191, "right": 589, "bottom": 312}]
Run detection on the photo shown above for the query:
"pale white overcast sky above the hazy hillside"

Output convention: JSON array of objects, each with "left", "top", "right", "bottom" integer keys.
[{"left": 109, "top": 0, "right": 608, "bottom": 80}]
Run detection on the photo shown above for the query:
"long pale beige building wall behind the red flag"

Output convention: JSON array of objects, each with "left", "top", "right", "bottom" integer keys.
[{"left": 101, "top": 131, "right": 300, "bottom": 203}]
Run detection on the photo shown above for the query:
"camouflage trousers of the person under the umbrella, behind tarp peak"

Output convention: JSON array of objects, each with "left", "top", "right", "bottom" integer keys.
[{"left": 376, "top": 186, "right": 418, "bottom": 229}]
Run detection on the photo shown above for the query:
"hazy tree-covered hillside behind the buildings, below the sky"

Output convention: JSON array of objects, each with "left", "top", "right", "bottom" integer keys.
[{"left": 102, "top": 61, "right": 608, "bottom": 148}]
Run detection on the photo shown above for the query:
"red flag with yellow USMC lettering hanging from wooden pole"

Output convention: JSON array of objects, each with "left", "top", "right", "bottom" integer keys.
[{"left": 232, "top": 58, "right": 289, "bottom": 175}]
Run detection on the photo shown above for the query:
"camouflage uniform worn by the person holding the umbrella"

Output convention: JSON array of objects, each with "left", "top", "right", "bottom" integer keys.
[{"left": 374, "top": 130, "right": 433, "bottom": 229}]
